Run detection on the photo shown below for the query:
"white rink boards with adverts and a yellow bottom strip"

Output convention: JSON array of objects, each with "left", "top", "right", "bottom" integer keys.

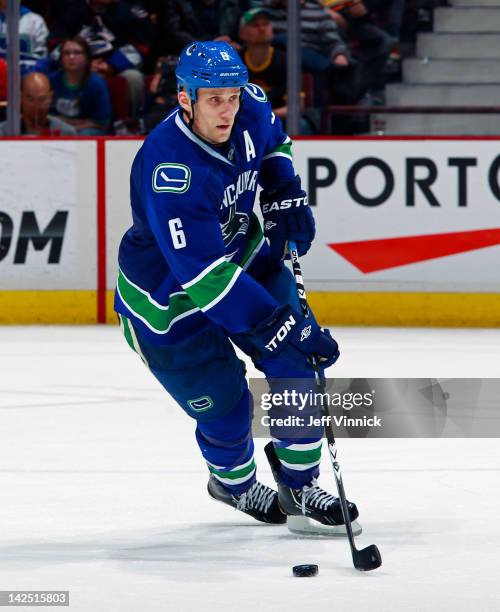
[{"left": 0, "top": 138, "right": 500, "bottom": 327}]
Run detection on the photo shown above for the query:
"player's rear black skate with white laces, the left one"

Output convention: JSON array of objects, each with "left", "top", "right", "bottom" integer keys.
[{"left": 207, "top": 476, "right": 286, "bottom": 525}]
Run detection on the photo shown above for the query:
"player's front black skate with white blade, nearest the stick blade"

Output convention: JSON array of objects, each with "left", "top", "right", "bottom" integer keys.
[{"left": 265, "top": 442, "right": 362, "bottom": 536}]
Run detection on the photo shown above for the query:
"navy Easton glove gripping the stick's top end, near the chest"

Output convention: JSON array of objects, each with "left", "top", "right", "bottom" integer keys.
[{"left": 260, "top": 176, "right": 316, "bottom": 263}]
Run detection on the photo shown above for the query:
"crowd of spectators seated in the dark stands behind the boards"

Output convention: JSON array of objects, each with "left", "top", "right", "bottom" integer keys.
[{"left": 0, "top": 0, "right": 446, "bottom": 136}]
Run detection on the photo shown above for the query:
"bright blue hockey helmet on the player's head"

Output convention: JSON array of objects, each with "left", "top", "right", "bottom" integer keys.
[{"left": 175, "top": 41, "right": 248, "bottom": 102}]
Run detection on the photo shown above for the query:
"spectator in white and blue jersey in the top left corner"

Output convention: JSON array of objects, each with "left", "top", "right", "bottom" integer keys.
[{"left": 0, "top": 0, "right": 49, "bottom": 74}]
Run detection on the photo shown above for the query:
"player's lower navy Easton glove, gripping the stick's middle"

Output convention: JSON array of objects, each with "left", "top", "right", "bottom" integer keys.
[{"left": 250, "top": 305, "right": 340, "bottom": 369}]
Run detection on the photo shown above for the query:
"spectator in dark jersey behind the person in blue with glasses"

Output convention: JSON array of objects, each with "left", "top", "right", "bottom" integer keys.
[{"left": 50, "top": 0, "right": 153, "bottom": 115}]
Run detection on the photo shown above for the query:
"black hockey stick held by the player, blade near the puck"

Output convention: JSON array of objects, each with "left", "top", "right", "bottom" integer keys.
[{"left": 288, "top": 240, "right": 382, "bottom": 572}]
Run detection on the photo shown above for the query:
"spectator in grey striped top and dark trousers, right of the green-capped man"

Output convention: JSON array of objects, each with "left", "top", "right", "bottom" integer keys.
[{"left": 253, "top": 0, "right": 359, "bottom": 104}]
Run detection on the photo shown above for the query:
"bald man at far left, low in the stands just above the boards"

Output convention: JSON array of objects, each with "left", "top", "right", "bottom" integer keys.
[{"left": 0, "top": 72, "right": 76, "bottom": 136}]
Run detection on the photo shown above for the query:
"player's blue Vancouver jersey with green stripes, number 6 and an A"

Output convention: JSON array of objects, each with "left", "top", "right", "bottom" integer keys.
[{"left": 115, "top": 84, "right": 295, "bottom": 345}]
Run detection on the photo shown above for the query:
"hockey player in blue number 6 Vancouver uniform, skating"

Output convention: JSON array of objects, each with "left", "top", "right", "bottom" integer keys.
[{"left": 115, "top": 42, "right": 358, "bottom": 525}]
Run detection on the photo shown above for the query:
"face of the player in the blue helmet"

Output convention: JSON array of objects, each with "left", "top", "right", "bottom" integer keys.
[{"left": 189, "top": 87, "right": 240, "bottom": 144}]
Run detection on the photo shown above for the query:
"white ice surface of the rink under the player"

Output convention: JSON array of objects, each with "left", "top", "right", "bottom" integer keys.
[{"left": 0, "top": 327, "right": 500, "bottom": 612}]
